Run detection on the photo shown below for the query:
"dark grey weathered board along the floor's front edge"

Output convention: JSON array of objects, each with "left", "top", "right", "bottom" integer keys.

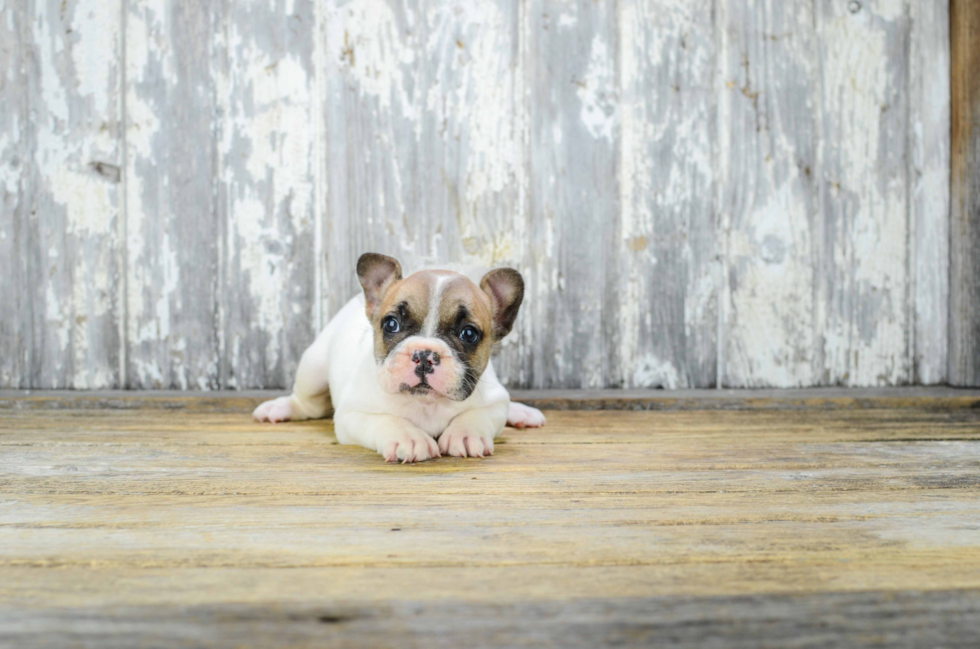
[{"left": 0, "top": 590, "right": 980, "bottom": 649}]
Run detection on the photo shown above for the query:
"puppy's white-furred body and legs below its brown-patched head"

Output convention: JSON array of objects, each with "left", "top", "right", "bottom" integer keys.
[{"left": 253, "top": 292, "right": 544, "bottom": 462}]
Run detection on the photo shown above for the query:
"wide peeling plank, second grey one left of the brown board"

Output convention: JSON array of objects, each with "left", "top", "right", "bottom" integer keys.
[{"left": 817, "top": 0, "right": 912, "bottom": 385}]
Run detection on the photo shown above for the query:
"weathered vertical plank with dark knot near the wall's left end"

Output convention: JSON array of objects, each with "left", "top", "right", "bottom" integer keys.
[{"left": 23, "top": 0, "right": 122, "bottom": 389}]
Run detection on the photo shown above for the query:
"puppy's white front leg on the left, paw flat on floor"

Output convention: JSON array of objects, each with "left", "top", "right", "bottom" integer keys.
[{"left": 334, "top": 411, "right": 439, "bottom": 462}]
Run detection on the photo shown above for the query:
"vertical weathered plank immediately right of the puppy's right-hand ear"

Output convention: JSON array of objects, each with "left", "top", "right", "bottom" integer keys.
[{"left": 526, "top": 0, "right": 622, "bottom": 388}]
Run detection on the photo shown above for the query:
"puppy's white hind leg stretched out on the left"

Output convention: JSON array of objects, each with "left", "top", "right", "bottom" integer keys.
[{"left": 252, "top": 335, "right": 333, "bottom": 424}]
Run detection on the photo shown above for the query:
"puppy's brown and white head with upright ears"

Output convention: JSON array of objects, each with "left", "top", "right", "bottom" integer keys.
[{"left": 357, "top": 253, "right": 524, "bottom": 401}]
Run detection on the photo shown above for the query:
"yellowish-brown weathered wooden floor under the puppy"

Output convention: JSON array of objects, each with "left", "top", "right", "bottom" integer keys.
[{"left": 0, "top": 398, "right": 980, "bottom": 649}]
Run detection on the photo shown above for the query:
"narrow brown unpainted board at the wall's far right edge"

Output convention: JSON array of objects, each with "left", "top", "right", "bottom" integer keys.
[{"left": 949, "top": 0, "right": 980, "bottom": 386}]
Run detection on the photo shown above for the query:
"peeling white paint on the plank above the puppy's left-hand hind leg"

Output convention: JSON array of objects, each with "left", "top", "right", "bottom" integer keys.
[{"left": 219, "top": 8, "right": 314, "bottom": 387}]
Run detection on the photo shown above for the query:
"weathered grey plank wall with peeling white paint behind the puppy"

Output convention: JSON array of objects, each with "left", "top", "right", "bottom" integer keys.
[{"left": 0, "top": 0, "right": 960, "bottom": 388}]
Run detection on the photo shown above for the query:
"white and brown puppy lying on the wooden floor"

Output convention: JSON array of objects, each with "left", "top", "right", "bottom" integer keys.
[{"left": 253, "top": 253, "right": 545, "bottom": 462}]
